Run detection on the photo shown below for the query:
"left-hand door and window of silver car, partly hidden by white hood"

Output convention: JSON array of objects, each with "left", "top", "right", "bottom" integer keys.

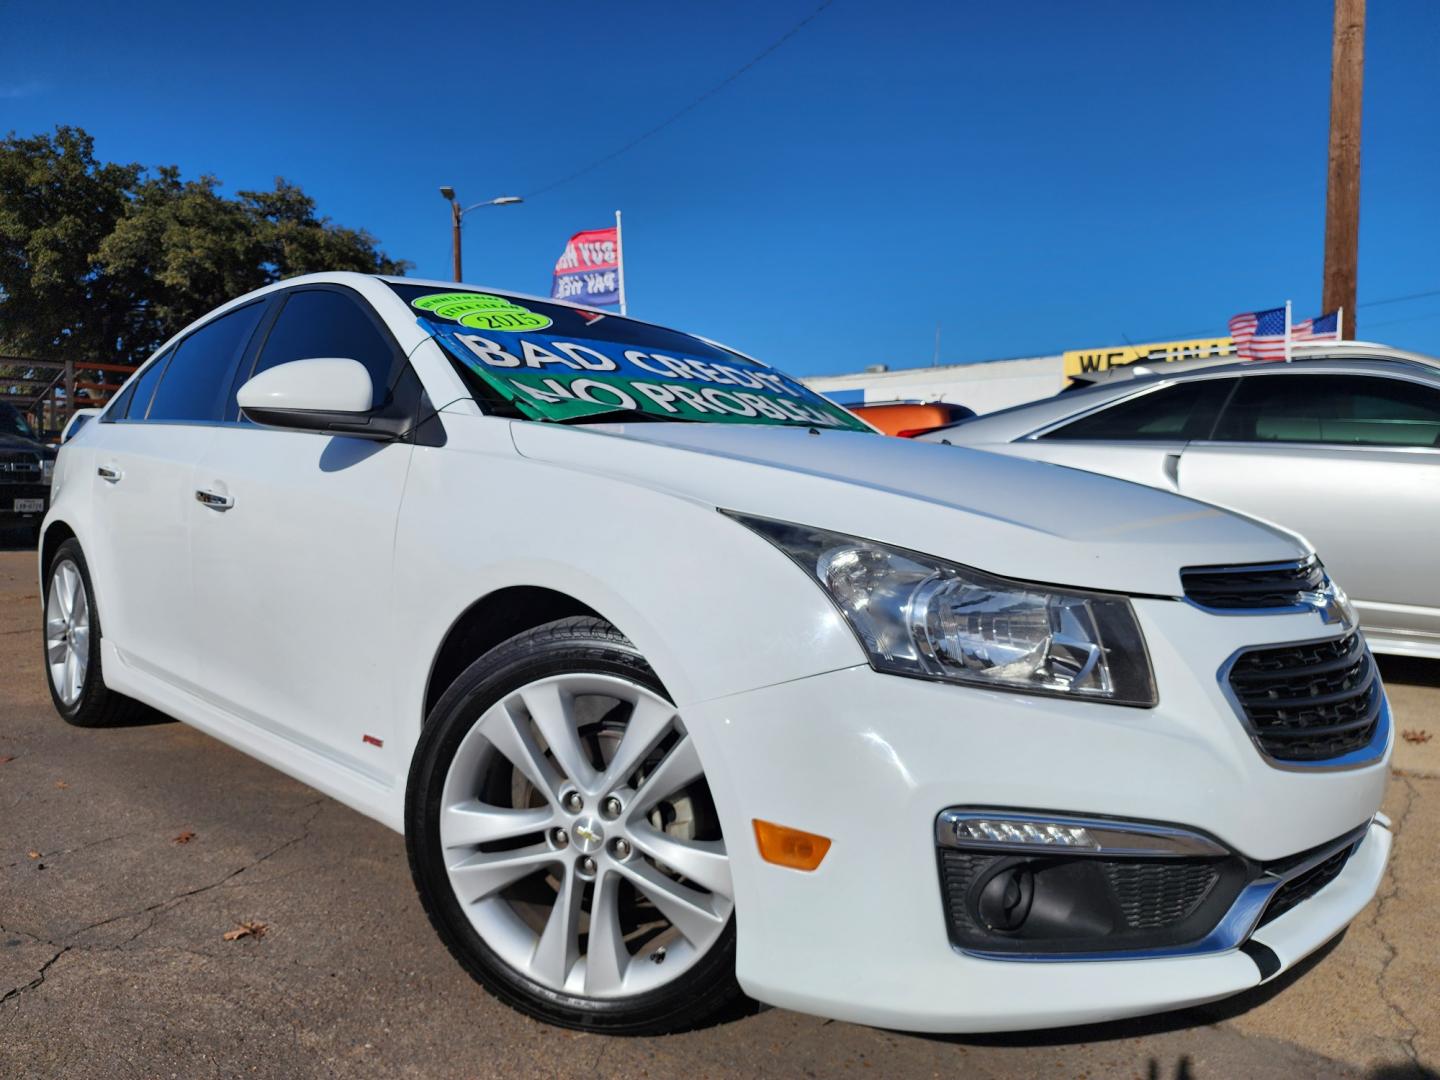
[{"left": 1007, "top": 379, "right": 1234, "bottom": 491}]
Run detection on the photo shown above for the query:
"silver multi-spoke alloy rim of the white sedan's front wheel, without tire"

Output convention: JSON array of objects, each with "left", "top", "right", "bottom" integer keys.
[{"left": 439, "top": 672, "right": 734, "bottom": 998}]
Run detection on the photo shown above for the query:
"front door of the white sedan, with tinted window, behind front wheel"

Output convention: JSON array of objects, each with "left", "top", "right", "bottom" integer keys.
[{"left": 192, "top": 285, "right": 418, "bottom": 779}]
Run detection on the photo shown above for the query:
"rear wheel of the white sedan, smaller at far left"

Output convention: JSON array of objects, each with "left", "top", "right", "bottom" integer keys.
[{"left": 45, "top": 539, "right": 144, "bottom": 727}]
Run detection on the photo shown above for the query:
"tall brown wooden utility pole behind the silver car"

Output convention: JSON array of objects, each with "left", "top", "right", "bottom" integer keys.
[{"left": 1320, "top": 0, "right": 1365, "bottom": 338}]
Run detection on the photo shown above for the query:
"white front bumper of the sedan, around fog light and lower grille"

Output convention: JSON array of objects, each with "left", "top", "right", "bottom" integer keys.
[{"left": 684, "top": 600, "right": 1390, "bottom": 1032}]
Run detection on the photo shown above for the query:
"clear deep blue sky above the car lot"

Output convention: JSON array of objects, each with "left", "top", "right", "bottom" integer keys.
[{"left": 0, "top": 0, "right": 1440, "bottom": 374}]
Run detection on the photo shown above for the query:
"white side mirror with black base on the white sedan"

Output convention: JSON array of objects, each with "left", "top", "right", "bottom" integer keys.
[{"left": 238, "top": 357, "right": 406, "bottom": 439}]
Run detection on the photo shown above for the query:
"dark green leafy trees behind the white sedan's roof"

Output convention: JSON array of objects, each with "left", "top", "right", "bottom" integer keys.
[{"left": 0, "top": 127, "right": 410, "bottom": 363}]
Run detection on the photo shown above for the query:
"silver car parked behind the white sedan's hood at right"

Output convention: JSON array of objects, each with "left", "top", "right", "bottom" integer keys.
[{"left": 920, "top": 351, "right": 1440, "bottom": 660}]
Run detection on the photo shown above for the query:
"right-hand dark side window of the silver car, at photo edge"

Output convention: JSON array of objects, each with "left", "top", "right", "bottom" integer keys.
[{"left": 1215, "top": 374, "right": 1440, "bottom": 446}]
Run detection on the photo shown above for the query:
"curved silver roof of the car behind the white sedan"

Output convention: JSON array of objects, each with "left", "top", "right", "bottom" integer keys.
[{"left": 922, "top": 347, "right": 1440, "bottom": 444}]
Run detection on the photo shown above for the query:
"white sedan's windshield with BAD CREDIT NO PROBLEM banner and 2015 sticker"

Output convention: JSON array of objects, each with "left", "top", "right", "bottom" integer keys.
[{"left": 390, "top": 282, "right": 870, "bottom": 431}]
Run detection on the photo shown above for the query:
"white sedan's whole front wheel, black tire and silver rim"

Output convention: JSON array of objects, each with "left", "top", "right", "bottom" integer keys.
[{"left": 406, "top": 618, "right": 740, "bottom": 1034}]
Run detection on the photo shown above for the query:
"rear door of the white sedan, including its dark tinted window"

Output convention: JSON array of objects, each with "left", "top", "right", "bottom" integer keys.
[{"left": 86, "top": 301, "right": 265, "bottom": 688}]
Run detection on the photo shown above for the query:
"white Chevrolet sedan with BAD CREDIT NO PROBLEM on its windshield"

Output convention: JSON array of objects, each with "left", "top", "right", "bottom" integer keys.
[{"left": 40, "top": 274, "right": 1392, "bottom": 1032}]
